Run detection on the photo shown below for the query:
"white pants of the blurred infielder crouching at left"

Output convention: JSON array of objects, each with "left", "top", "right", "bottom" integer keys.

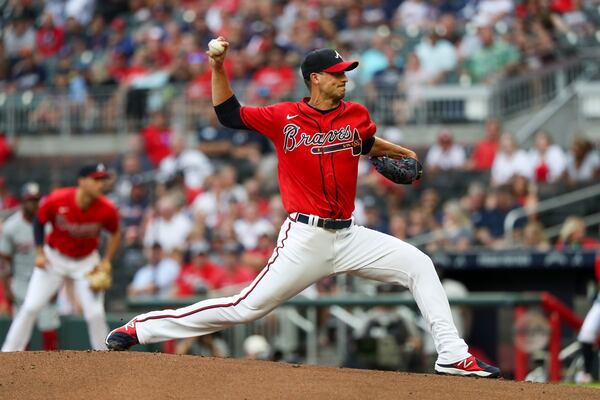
[{"left": 2, "top": 246, "right": 108, "bottom": 351}]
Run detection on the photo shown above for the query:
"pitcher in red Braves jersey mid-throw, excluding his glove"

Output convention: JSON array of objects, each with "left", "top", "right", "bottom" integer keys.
[{"left": 106, "top": 37, "right": 500, "bottom": 378}]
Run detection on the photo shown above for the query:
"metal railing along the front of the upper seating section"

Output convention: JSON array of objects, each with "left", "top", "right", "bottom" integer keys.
[{"left": 0, "top": 57, "right": 597, "bottom": 137}]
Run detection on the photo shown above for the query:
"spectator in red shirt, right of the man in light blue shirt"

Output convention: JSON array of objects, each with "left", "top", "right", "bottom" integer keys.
[{"left": 173, "top": 241, "right": 227, "bottom": 297}]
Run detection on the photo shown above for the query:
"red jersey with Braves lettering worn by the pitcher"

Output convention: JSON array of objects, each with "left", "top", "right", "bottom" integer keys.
[{"left": 240, "top": 98, "right": 376, "bottom": 219}]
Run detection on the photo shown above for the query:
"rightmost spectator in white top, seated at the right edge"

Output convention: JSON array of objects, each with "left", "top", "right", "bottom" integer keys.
[{"left": 564, "top": 137, "right": 600, "bottom": 186}]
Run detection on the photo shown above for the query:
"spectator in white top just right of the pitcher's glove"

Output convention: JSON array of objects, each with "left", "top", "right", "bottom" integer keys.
[{"left": 425, "top": 128, "right": 466, "bottom": 173}]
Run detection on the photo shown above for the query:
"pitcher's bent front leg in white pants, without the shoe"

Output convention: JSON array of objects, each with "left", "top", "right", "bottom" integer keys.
[{"left": 335, "top": 226, "right": 470, "bottom": 364}]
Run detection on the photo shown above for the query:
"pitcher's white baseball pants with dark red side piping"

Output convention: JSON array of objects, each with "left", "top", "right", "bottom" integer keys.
[{"left": 135, "top": 215, "right": 470, "bottom": 364}]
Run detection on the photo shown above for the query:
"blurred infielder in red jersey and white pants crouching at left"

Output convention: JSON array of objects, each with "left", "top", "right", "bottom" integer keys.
[{"left": 2, "top": 164, "right": 121, "bottom": 351}]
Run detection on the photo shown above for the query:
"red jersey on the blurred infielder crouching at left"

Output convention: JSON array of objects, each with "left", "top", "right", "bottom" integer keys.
[{"left": 37, "top": 187, "right": 119, "bottom": 258}]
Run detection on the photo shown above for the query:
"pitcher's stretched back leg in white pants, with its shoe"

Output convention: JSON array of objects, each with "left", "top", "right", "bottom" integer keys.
[{"left": 107, "top": 221, "right": 333, "bottom": 350}]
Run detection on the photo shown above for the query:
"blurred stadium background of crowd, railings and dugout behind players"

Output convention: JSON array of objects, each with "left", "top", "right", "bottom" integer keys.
[{"left": 0, "top": 0, "right": 600, "bottom": 381}]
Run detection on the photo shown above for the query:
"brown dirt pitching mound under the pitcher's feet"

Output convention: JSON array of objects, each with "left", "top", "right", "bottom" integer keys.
[{"left": 0, "top": 351, "right": 600, "bottom": 400}]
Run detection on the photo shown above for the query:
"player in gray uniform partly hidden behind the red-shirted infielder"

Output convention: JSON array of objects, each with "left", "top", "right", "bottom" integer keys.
[{"left": 0, "top": 182, "right": 60, "bottom": 350}]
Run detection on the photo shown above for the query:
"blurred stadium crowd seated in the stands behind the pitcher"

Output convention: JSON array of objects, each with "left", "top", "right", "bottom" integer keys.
[{"left": 0, "top": 0, "right": 600, "bottom": 368}]
